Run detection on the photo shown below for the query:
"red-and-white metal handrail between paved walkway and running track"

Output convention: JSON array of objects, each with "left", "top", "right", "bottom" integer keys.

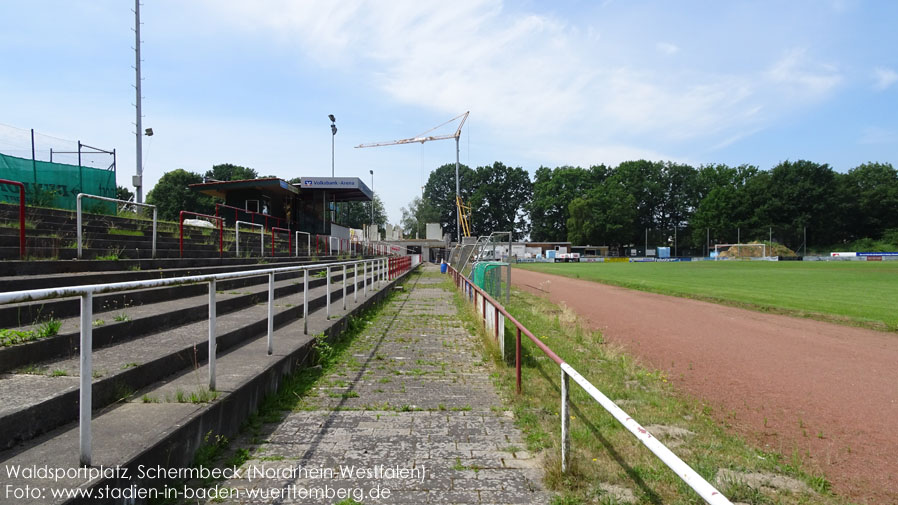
[{"left": 448, "top": 266, "right": 732, "bottom": 505}]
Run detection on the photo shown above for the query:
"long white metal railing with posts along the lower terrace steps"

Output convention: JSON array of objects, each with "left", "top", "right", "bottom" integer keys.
[{"left": 0, "top": 258, "right": 387, "bottom": 466}]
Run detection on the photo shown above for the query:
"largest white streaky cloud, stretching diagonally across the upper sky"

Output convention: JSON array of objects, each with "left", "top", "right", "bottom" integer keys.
[{"left": 203, "top": 0, "right": 757, "bottom": 143}]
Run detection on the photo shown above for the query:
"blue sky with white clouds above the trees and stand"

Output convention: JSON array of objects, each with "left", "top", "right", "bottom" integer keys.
[{"left": 0, "top": 0, "right": 898, "bottom": 222}]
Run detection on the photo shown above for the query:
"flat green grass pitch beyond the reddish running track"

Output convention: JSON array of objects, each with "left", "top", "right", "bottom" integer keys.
[{"left": 516, "top": 261, "right": 898, "bottom": 331}]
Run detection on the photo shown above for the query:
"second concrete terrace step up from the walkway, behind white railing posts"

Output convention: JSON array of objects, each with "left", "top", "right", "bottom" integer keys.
[{"left": 0, "top": 264, "right": 384, "bottom": 447}]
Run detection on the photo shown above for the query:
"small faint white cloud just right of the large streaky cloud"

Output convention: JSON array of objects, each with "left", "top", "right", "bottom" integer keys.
[{"left": 767, "top": 49, "right": 842, "bottom": 99}]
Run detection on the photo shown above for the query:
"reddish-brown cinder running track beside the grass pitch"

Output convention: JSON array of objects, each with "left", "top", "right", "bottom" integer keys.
[{"left": 512, "top": 270, "right": 898, "bottom": 505}]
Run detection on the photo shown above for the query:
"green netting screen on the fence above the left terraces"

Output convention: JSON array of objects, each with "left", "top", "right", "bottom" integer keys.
[{"left": 0, "top": 154, "right": 116, "bottom": 214}]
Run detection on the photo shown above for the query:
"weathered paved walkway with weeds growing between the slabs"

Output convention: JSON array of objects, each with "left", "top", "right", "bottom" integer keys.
[{"left": 217, "top": 265, "right": 550, "bottom": 505}]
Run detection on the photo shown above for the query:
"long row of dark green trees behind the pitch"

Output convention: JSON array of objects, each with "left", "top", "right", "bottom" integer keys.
[{"left": 402, "top": 160, "right": 898, "bottom": 254}]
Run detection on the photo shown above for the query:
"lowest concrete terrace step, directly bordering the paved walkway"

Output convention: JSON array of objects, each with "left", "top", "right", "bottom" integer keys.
[{"left": 0, "top": 266, "right": 402, "bottom": 504}]
